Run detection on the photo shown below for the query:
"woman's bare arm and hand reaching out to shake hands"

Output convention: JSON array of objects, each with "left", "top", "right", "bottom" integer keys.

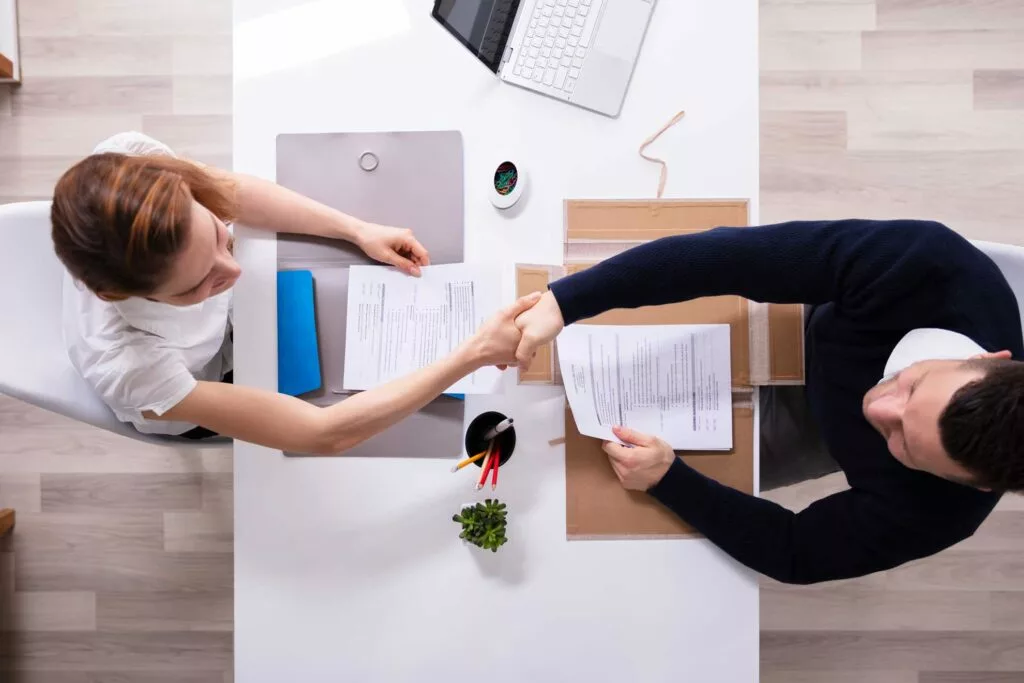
[{"left": 146, "top": 295, "right": 540, "bottom": 455}]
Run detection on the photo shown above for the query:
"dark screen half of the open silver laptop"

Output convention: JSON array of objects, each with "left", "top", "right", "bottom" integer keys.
[{"left": 432, "top": 0, "right": 519, "bottom": 74}]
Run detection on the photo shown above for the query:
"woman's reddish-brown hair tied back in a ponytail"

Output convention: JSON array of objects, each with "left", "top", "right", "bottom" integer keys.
[{"left": 50, "top": 154, "right": 236, "bottom": 300}]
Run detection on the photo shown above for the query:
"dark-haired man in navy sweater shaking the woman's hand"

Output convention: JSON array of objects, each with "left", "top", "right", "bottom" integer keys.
[{"left": 516, "top": 220, "right": 1024, "bottom": 584}]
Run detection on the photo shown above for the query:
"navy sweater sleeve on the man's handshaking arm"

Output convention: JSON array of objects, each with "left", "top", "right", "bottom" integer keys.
[{"left": 551, "top": 220, "right": 973, "bottom": 325}]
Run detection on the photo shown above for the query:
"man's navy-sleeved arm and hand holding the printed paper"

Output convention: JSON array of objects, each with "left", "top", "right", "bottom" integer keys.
[{"left": 604, "top": 427, "right": 998, "bottom": 584}]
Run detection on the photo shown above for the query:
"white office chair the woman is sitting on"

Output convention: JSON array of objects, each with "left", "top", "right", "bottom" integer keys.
[{"left": 0, "top": 202, "right": 208, "bottom": 446}]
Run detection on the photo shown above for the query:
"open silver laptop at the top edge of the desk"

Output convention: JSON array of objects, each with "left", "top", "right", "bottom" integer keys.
[{"left": 432, "top": 0, "right": 654, "bottom": 117}]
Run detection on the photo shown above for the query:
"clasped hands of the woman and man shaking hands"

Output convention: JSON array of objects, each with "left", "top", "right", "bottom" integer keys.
[{"left": 466, "top": 291, "right": 565, "bottom": 370}]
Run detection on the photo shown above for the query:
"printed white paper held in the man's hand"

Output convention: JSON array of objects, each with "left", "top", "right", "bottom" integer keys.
[{"left": 557, "top": 325, "right": 732, "bottom": 451}]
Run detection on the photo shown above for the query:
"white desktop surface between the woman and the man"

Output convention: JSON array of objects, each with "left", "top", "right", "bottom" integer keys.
[{"left": 234, "top": 0, "right": 758, "bottom": 683}]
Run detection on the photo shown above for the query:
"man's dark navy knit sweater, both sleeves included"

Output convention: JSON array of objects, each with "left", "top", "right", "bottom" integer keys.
[{"left": 551, "top": 220, "right": 1024, "bottom": 584}]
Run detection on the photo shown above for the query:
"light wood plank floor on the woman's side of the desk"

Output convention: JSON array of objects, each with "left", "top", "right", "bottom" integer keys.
[{"left": 0, "top": 0, "right": 233, "bottom": 683}]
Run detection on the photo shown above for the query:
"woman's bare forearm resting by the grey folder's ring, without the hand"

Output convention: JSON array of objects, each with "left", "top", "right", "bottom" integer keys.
[{"left": 231, "top": 173, "right": 362, "bottom": 244}]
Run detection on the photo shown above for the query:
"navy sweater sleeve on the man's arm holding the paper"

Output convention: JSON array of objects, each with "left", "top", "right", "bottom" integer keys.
[{"left": 648, "top": 459, "right": 984, "bottom": 584}]
